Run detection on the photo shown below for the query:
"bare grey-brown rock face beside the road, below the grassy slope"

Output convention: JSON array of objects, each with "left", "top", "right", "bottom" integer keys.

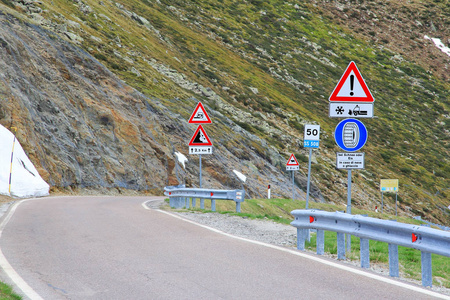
[{"left": 0, "top": 13, "right": 321, "bottom": 199}]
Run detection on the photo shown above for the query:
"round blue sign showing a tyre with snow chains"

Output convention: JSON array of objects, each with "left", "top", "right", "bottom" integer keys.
[{"left": 334, "top": 119, "right": 367, "bottom": 152}]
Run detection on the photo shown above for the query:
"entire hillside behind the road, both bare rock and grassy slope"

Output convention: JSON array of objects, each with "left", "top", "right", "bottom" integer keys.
[{"left": 0, "top": 0, "right": 450, "bottom": 224}]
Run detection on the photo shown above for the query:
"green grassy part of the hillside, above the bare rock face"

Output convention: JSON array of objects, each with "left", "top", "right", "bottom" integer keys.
[{"left": 2, "top": 0, "right": 450, "bottom": 224}]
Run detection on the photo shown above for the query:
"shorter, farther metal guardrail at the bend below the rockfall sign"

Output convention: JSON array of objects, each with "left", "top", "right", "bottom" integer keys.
[{"left": 164, "top": 186, "right": 245, "bottom": 212}]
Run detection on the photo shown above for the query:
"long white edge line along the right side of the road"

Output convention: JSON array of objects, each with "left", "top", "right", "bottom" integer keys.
[{"left": 142, "top": 200, "right": 450, "bottom": 300}]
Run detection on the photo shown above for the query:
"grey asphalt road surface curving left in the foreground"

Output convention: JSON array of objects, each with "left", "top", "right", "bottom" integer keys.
[{"left": 0, "top": 197, "right": 444, "bottom": 300}]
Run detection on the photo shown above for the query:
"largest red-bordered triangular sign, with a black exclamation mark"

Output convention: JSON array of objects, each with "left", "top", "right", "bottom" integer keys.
[{"left": 329, "top": 61, "right": 375, "bottom": 102}]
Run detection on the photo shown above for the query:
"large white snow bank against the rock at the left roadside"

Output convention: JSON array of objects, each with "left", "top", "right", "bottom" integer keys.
[{"left": 0, "top": 125, "right": 50, "bottom": 198}]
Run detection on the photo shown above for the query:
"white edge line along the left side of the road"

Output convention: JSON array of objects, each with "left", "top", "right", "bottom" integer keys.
[{"left": 0, "top": 199, "right": 43, "bottom": 300}]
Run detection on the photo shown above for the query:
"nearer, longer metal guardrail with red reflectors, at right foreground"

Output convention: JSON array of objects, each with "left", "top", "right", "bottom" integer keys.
[{"left": 291, "top": 210, "right": 450, "bottom": 286}]
